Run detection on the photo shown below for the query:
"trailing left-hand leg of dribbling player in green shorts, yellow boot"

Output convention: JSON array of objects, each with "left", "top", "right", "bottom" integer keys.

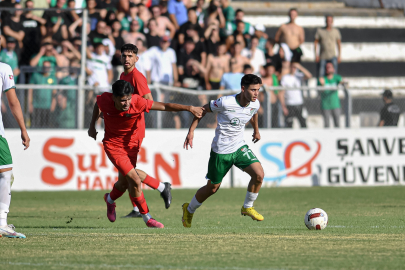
[{"left": 182, "top": 150, "right": 233, "bottom": 227}]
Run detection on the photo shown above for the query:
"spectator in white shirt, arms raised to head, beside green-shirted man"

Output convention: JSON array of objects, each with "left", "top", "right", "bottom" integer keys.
[{"left": 279, "top": 62, "right": 312, "bottom": 128}]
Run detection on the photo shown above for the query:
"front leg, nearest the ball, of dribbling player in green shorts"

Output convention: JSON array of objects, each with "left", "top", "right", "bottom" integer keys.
[{"left": 235, "top": 145, "right": 264, "bottom": 221}]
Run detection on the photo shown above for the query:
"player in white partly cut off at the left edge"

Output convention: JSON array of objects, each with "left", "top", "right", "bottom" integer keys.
[{"left": 0, "top": 62, "right": 30, "bottom": 238}]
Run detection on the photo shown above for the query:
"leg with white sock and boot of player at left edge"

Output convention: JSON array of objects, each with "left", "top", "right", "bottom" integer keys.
[{"left": 0, "top": 136, "right": 25, "bottom": 238}]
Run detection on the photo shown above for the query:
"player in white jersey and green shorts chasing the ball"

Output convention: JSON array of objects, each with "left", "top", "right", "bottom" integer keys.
[{"left": 182, "top": 74, "right": 264, "bottom": 227}]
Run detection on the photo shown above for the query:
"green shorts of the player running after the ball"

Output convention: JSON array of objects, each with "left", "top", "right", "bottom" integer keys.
[{"left": 205, "top": 145, "right": 259, "bottom": 184}]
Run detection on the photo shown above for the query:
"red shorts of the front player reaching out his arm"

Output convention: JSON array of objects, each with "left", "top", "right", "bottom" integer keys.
[{"left": 104, "top": 142, "right": 140, "bottom": 176}]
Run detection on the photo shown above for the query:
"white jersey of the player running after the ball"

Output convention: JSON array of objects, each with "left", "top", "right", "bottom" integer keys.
[{"left": 209, "top": 94, "right": 260, "bottom": 154}]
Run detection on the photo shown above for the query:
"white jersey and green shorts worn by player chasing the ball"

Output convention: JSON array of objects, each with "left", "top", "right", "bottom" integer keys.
[{"left": 206, "top": 94, "right": 260, "bottom": 184}]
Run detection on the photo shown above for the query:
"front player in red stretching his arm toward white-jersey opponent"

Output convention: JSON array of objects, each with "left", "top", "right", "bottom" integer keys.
[{"left": 88, "top": 80, "right": 203, "bottom": 228}]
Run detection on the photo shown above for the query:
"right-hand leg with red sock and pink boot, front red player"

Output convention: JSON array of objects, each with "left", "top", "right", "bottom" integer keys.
[{"left": 125, "top": 169, "right": 164, "bottom": 228}]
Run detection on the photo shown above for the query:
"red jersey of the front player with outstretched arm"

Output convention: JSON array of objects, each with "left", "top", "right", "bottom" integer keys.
[{"left": 97, "top": 93, "right": 153, "bottom": 147}]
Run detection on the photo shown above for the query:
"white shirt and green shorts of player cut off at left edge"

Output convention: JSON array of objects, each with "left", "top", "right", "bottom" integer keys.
[{"left": 0, "top": 62, "right": 15, "bottom": 169}]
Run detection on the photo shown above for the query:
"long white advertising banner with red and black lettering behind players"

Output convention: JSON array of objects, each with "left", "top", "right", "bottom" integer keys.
[{"left": 6, "top": 128, "right": 405, "bottom": 190}]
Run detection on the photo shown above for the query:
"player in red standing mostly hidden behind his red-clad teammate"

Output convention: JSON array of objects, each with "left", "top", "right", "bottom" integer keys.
[{"left": 118, "top": 44, "right": 168, "bottom": 218}]
